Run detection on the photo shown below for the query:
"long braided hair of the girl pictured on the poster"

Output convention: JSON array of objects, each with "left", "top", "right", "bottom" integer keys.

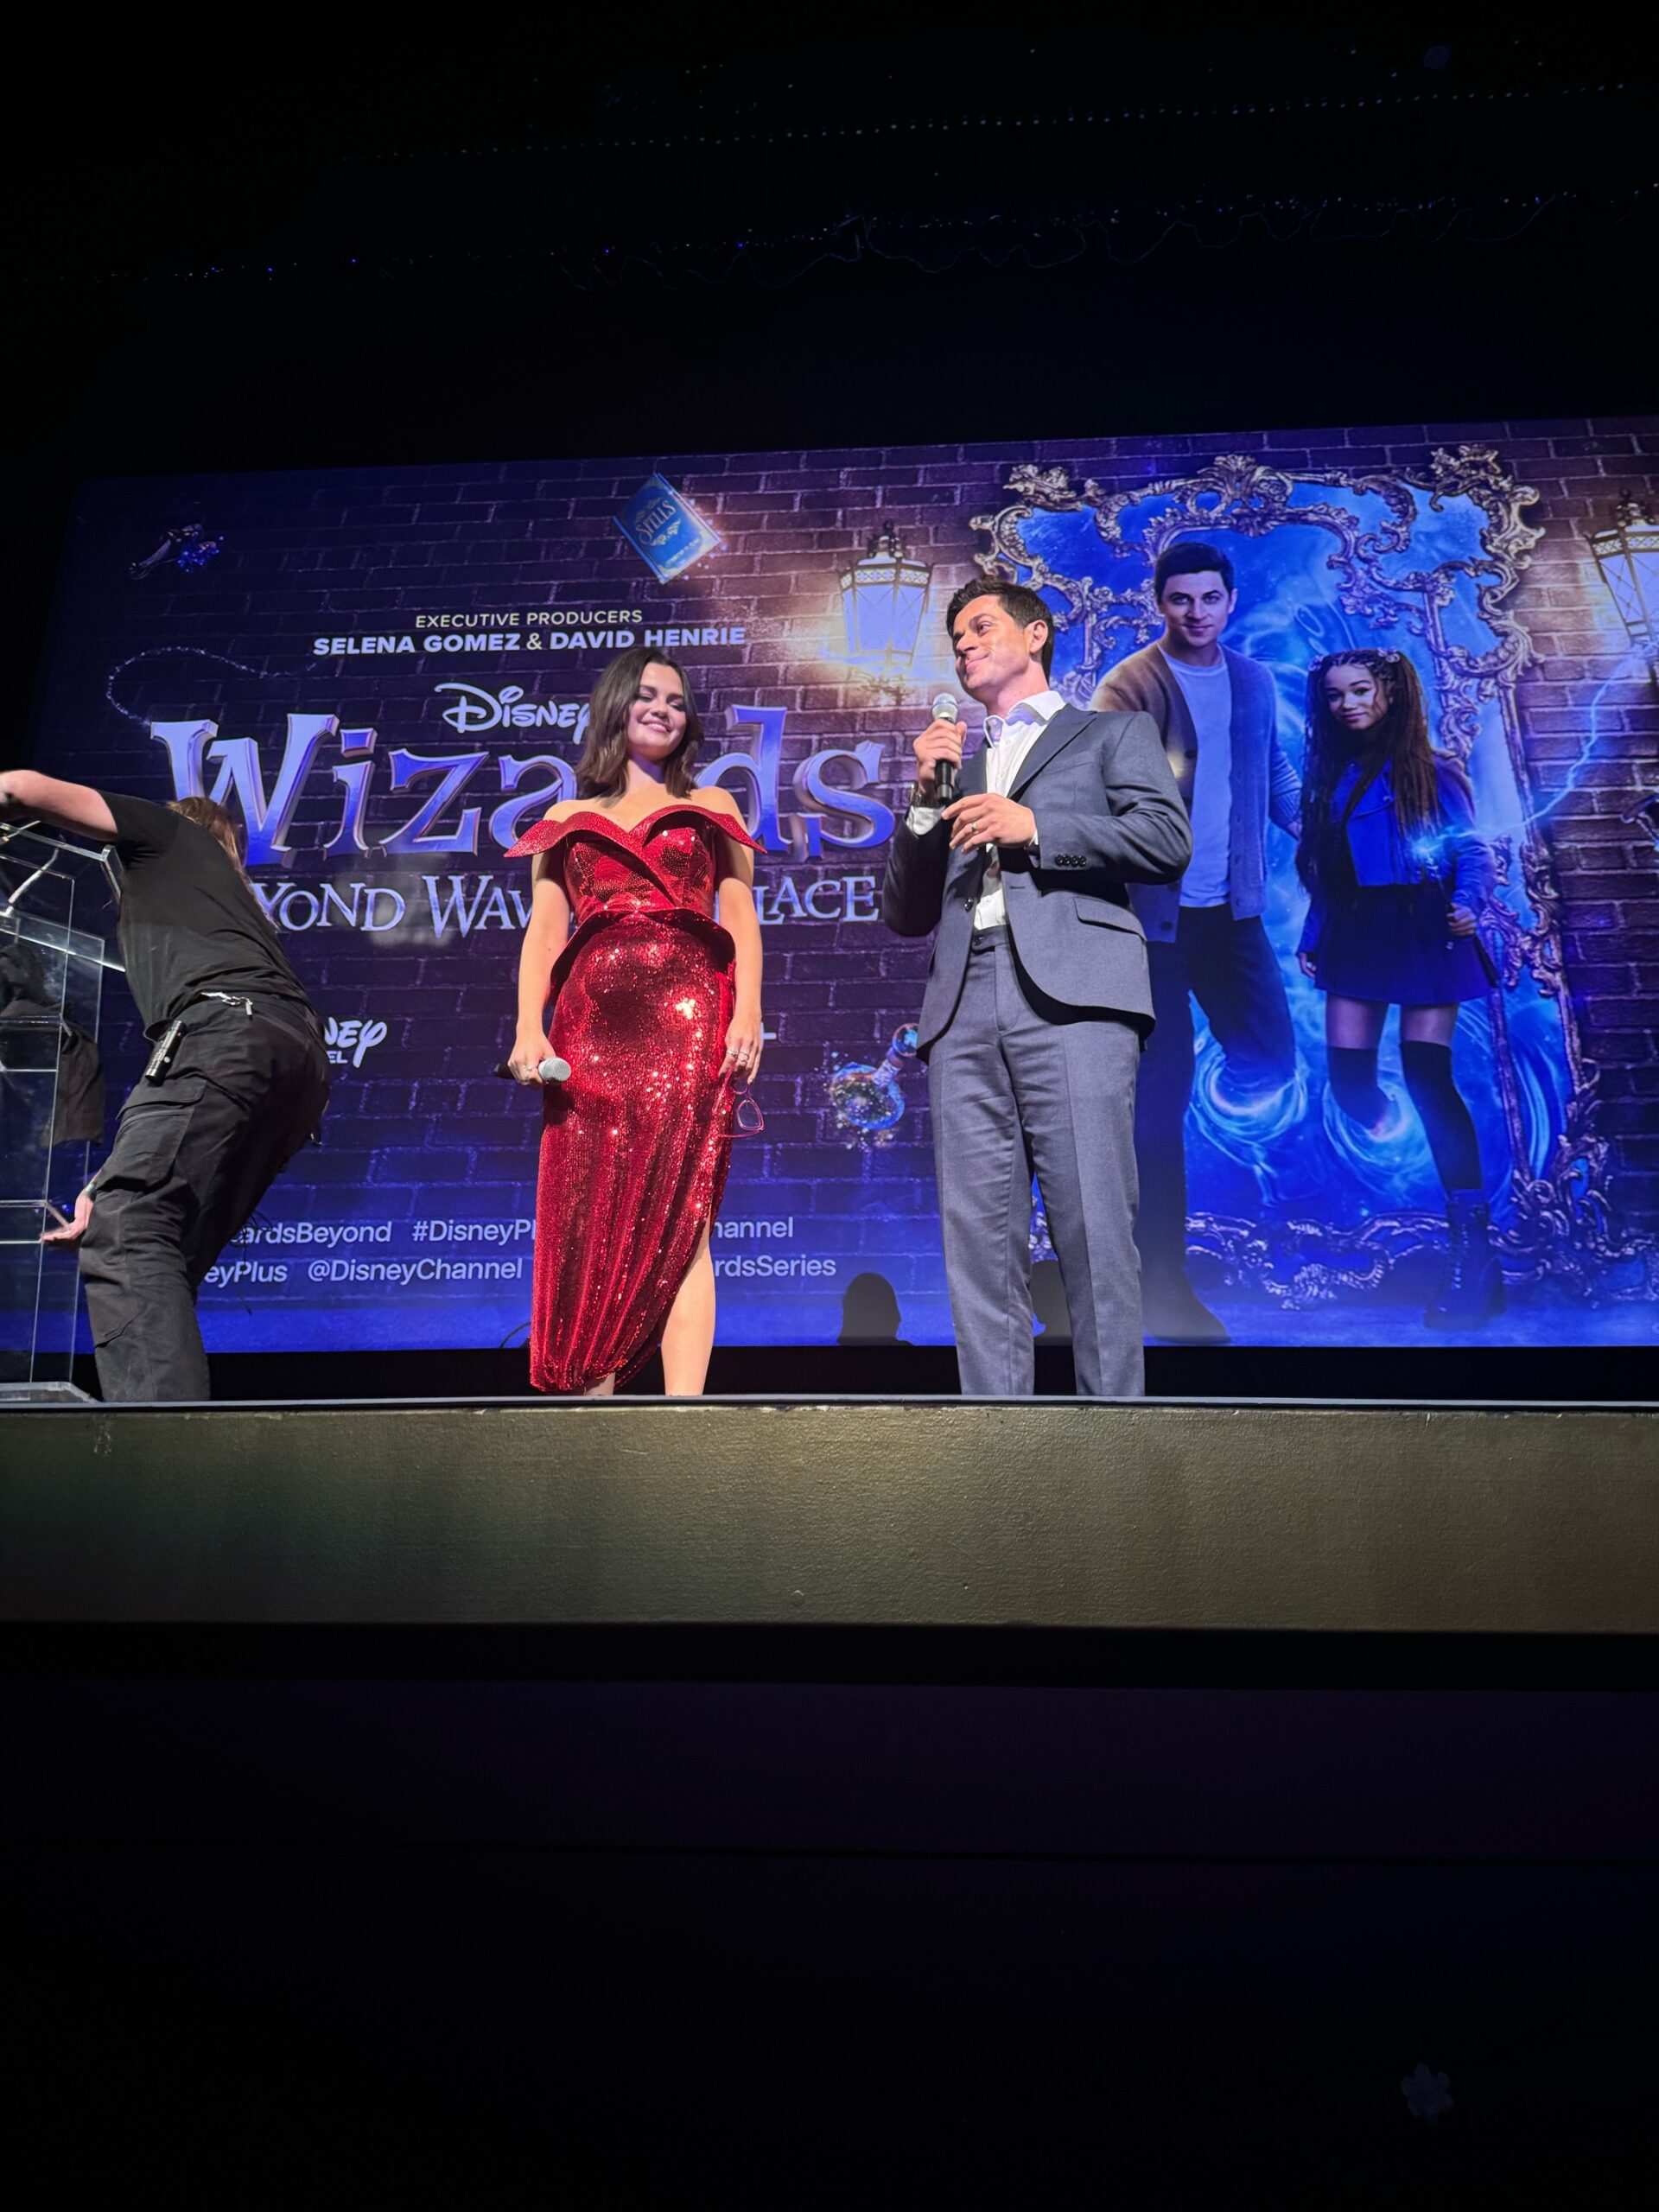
[{"left": 1296, "top": 646, "right": 1462, "bottom": 896}]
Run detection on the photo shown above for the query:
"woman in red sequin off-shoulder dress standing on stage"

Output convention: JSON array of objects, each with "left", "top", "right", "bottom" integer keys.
[{"left": 509, "top": 646, "right": 761, "bottom": 1398}]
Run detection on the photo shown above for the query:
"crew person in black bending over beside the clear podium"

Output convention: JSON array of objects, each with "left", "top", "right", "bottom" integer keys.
[{"left": 0, "top": 770, "right": 327, "bottom": 1400}]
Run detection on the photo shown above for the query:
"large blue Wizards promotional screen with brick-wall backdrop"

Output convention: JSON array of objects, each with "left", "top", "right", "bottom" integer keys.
[{"left": 33, "top": 420, "right": 1659, "bottom": 1351}]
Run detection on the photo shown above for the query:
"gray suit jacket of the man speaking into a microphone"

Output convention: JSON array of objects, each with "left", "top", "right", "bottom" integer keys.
[{"left": 880, "top": 706, "right": 1192, "bottom": 1058}]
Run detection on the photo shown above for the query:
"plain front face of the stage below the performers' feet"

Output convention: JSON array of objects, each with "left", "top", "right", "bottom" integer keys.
[{"left": 0, "top": 1398, "right": 1659, "bottom": 1666}]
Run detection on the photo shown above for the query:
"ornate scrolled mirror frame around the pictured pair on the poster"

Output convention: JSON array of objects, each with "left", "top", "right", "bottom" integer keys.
[{"left": 973, "top": 445, "right": 1659, "bottom": 1310}]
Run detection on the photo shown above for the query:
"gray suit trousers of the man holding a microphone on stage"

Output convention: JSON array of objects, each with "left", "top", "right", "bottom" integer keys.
[{"left": 927, "top": 931, "right": 1146, "bottom": 1398}]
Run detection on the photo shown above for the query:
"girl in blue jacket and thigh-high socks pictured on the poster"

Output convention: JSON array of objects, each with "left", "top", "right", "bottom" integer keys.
[{"left": 1296, "top": 646, "right": 1504, "bottom": 1330}]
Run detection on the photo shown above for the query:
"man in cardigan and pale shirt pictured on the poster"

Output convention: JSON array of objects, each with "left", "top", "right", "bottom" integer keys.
[{"left": 1095, "top": 537, "right": 1300, "bottom": 1344}]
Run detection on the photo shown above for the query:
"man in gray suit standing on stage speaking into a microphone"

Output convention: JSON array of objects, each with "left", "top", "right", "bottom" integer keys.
[{"left": 880, "top": 580, "right": 1192, "bottom": 1398}]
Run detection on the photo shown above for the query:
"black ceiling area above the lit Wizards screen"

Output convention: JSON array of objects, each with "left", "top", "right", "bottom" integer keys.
[{"left": 11, "top": 11, "right": 1656, "bottom": 480}]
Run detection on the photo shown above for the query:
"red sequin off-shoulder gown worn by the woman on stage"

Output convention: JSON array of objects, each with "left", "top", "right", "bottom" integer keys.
[{"left": 509, "top": 801, "right": 763, "bottom": 1391}]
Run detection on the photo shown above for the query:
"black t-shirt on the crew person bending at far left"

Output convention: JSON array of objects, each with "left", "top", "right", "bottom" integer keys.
[{"left": 99, "top": 791, "right": 316, "bottom": 1033}]
